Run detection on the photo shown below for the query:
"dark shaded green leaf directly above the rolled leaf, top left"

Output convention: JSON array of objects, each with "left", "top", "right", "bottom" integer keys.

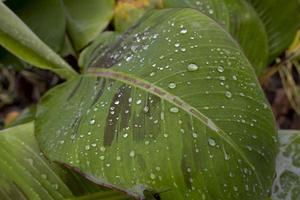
[{"left": 5, "top": 0, "right": 66, "bottom": 52}]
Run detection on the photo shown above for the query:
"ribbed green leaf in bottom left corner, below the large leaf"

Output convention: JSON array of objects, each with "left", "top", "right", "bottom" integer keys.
[{"left": 0, "top": 123, "right": 73, "bottom": 200}]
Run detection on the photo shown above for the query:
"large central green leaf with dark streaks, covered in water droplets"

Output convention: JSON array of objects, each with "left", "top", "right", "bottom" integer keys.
[{"left": 35, "top": 9, "right": 277, "bottom": 200}]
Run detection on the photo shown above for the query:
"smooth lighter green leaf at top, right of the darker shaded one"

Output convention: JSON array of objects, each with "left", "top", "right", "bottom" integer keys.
[{"left": 63, "top": 0, "right": 115, "bottom": 50}]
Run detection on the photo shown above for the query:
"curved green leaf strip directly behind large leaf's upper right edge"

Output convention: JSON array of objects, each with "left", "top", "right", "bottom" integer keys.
[{"left": 163, "top": 0, "right": 268, "bottom": 74}]
